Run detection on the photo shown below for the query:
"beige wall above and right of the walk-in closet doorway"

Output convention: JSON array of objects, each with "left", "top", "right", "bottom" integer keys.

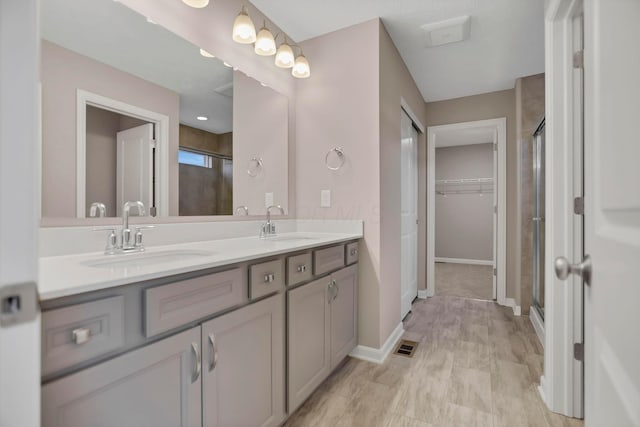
[{"left": 425, "top": 89, "right": 520, "bottom": 298}]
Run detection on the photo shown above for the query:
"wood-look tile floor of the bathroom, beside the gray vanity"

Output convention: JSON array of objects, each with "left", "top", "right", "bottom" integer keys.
[{"left": 285, "top": 296, "right": 583, "bottom": 427}]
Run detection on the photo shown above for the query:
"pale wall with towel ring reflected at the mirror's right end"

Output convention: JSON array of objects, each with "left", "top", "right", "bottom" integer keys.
[{"left": 233, "top": 71, "right": 289, "bottom": 215}]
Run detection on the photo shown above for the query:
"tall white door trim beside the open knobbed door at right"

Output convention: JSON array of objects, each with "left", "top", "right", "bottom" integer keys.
[{"left": 538, "top": 0, "right": 582, "bottom": 417}]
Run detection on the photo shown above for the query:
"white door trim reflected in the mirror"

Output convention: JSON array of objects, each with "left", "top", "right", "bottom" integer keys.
[{"left": 76, "top": 89, "right": 169, "bottom": 218}]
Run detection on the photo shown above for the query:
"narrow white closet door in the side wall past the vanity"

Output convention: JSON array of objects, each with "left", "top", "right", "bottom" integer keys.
[{"left": 400, "top": 111, "right": 418, "bottom": 318}]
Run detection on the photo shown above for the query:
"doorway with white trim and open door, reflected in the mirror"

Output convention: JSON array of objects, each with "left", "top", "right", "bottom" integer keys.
[{"left": 76, "top": 90, "right": 169, "bottom": 218}]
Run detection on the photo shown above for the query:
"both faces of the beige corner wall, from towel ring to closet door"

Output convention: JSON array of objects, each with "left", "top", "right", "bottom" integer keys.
[{"left": 296, "top": 19, "right": 425, "bottom": 348}]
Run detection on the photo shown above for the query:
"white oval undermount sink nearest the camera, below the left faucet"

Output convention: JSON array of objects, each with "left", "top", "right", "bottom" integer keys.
[{"left": 82, "top": 249, "right": 215, "bottom": 268}]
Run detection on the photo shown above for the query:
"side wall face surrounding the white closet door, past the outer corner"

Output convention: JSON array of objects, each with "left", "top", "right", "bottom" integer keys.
[{"left": 379, "top": 21, "right": 426, "bottom": 345}]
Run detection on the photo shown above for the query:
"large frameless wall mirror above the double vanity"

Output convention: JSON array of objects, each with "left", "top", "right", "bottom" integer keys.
[{"left": 41, "top": 0, "right": 289, "bottom": 219}]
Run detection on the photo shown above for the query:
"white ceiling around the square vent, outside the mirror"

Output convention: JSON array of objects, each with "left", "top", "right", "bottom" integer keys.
[{"left": 251, "top": 0, "right": 544, "bottom": 101}]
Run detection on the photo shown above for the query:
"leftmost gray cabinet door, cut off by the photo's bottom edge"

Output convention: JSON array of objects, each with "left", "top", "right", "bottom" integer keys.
[{"left": 42, "top": 326, "right": 202, "bottom": 427}]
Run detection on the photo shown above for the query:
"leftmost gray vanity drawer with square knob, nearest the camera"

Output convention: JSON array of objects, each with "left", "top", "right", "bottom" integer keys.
[{"left": 42, "top": 296, "right": 124, "bottom": 375}]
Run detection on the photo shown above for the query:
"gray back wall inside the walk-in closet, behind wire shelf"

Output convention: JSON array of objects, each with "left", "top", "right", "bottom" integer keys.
[{"left": 435, "top": 143, "right": 493, "bottom": 261}]
